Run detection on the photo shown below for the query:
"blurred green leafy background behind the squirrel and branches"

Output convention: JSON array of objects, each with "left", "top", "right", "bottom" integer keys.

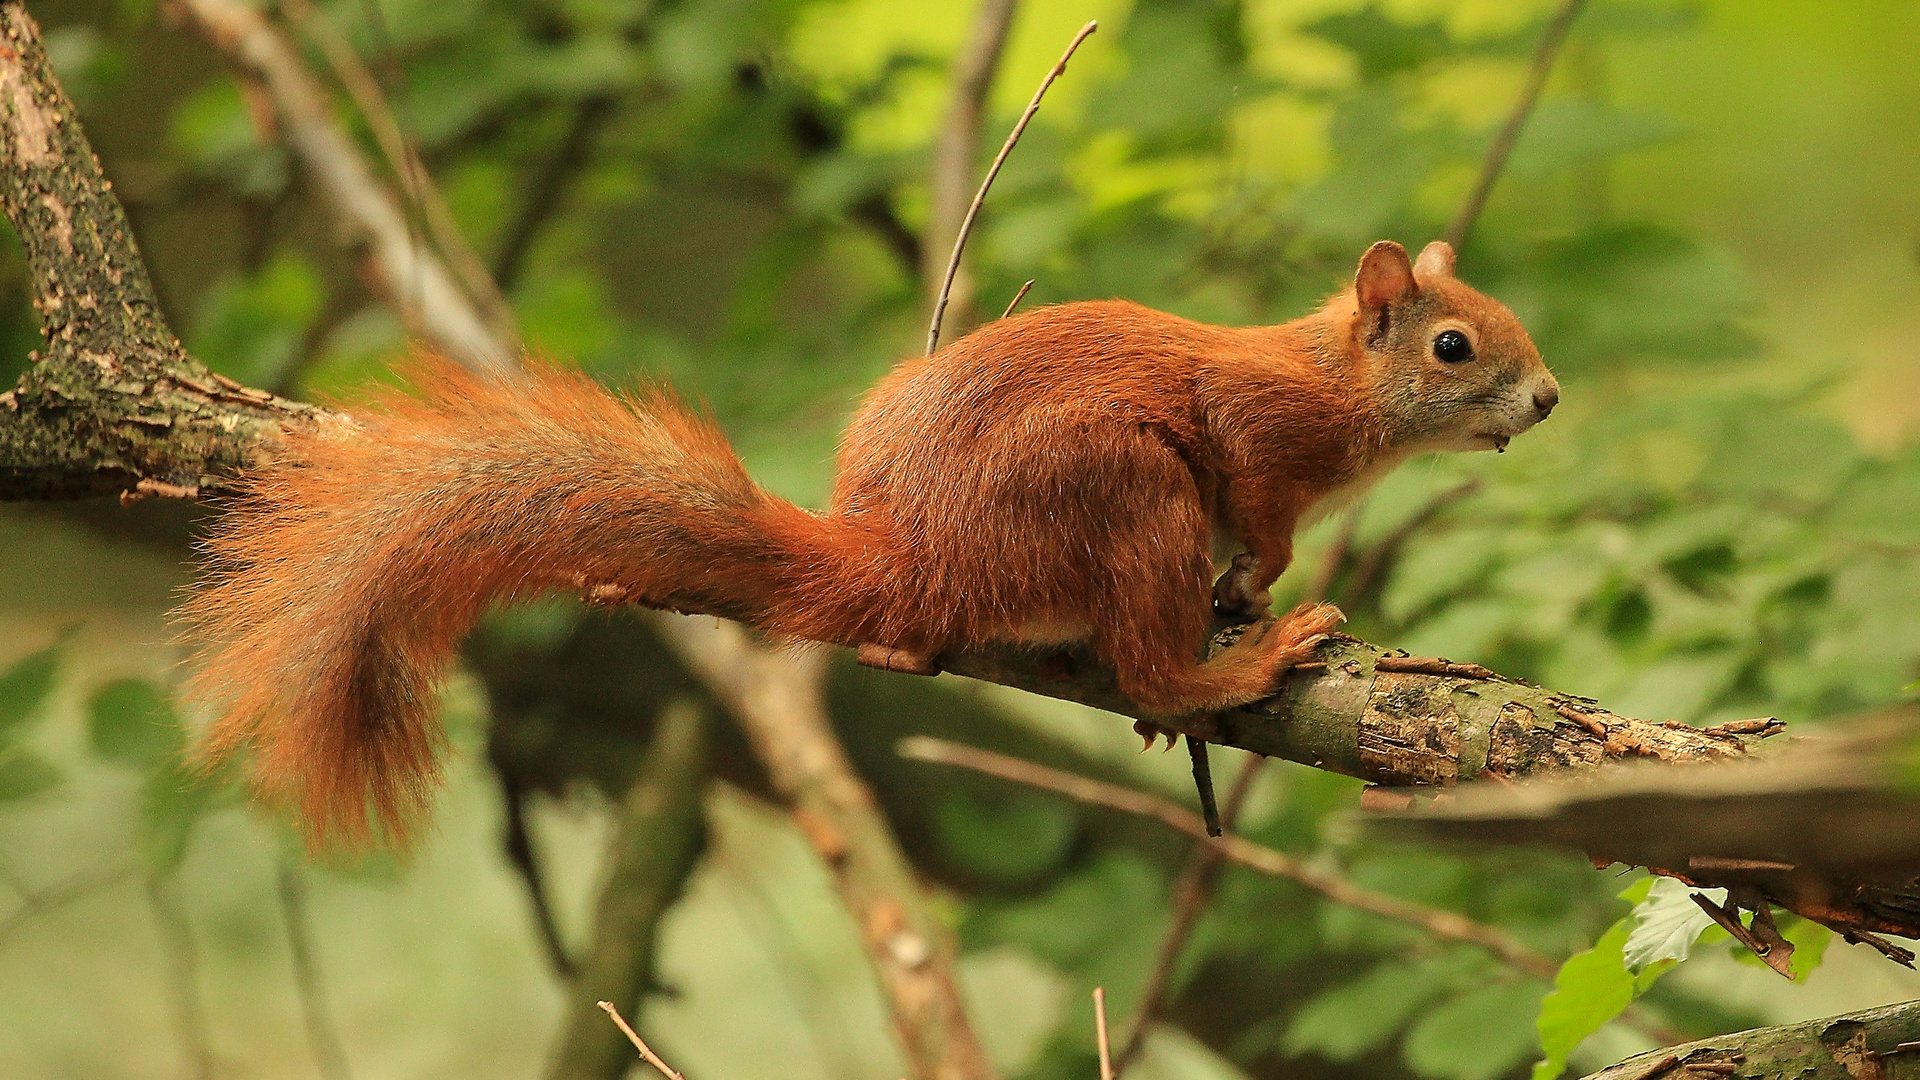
[{"left": 0, "top": 0, "right": 1920, "bottom": 1080}]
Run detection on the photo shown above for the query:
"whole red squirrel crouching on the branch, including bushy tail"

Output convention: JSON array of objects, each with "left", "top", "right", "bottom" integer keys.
[{"left": 184, "top": 240, "right": 1559, "bottom": 842}]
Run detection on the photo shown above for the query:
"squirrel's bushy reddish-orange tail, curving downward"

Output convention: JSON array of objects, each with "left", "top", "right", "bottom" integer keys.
[{"left": 182, "top": 361, "right": 828, "bottom": 846}]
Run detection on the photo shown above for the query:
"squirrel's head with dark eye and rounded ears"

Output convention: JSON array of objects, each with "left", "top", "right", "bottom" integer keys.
[{"left": 1354, "top": 240, "right": 1559, "bottom": 452}]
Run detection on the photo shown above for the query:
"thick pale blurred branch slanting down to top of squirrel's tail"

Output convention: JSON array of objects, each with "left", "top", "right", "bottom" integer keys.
[{"left": 173, "top": 0, "right": 515, "bottom": 371}]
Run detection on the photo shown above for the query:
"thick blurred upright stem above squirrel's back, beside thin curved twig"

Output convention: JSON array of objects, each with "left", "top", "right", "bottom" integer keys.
[{"left": 920, "top": 0, "right": 1020, "bottom": 307}]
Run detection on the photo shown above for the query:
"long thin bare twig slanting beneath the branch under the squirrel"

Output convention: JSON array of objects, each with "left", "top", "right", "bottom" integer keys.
[{"left": 900, "top": 736, "right": 1559, "bottom": 978}]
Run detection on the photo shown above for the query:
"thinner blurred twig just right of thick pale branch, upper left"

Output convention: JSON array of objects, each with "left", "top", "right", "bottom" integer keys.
[{"left": 278, "top": 0, "right": 515, "bottom": 336}]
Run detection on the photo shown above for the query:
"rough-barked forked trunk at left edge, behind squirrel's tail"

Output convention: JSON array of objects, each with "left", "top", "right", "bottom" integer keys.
[{"left": 0, "top": 2, "right": 328, "bottom": 500}]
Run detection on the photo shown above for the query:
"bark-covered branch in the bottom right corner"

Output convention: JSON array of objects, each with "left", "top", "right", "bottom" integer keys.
[{"left": 1586, "top": 1001, "right": 1920, "bottom": 1080}]
